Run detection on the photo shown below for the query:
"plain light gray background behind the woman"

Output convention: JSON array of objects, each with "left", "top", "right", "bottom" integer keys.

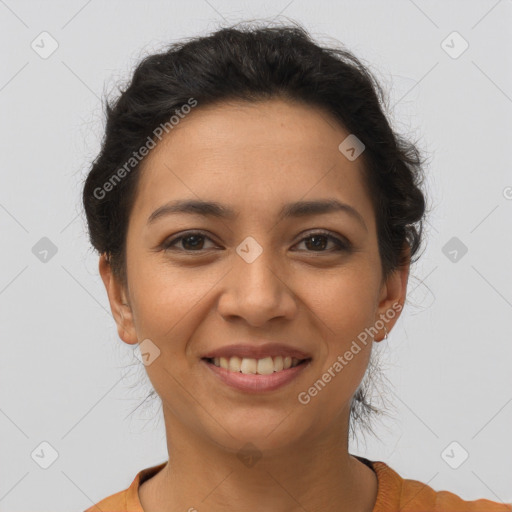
[{"left": 0, "top": 0, "right": 512, "bottom": 512}]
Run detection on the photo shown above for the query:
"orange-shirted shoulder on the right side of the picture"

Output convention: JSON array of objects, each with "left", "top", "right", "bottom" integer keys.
[{"left": 370, "top": 461, "right": 512, "bottom": 512}]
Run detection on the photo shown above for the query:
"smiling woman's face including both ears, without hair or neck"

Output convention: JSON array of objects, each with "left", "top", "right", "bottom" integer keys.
[{"left": 100, "top": 100, "right": 407, "bottom": 450}]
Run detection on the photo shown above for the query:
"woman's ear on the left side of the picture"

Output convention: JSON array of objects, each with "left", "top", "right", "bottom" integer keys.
[{"left": 99, "top": 253, "right": 139, "bottom": 345}]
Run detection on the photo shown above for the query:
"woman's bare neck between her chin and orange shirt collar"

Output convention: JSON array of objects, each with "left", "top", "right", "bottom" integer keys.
[{"left": 139, "top": 411, "right": 377, "bottom": 512}]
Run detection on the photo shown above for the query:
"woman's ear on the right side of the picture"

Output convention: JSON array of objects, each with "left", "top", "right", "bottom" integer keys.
[{"left": 375, "top": 243, "right": 411, "bottom": 341}]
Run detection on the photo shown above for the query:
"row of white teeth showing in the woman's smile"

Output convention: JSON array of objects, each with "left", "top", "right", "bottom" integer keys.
[{"left": 203, "top": 356, "right": 311, "bottom": 375}]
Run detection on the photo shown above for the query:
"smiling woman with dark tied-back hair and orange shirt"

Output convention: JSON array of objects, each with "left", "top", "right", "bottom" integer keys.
[{"left": 83, "top": 21, "right": 512, "bottom": 512}]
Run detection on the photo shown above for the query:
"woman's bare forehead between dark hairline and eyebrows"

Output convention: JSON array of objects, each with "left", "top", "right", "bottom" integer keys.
[{"left": 132, "top": 100, "right": 372, "bottom": 228}]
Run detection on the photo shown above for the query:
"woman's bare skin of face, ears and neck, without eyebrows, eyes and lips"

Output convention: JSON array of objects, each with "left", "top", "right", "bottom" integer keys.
[{"left": 99, "top": 99, "right": 409, "bottom": 512}]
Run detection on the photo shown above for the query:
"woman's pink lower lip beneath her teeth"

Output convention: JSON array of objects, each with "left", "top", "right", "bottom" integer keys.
[{"left": 202, "top": 359, "right": 311, "bottom": 393}]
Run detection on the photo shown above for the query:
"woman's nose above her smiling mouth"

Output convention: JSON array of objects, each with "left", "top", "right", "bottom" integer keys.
[{"left": 217, "top": 251, "right": 297, "bottom": 327}]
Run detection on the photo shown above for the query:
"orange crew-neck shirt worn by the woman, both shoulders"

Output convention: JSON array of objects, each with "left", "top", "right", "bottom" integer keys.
[{"left": 85, "top": 455, "right": 512, "bottom": 512}]
